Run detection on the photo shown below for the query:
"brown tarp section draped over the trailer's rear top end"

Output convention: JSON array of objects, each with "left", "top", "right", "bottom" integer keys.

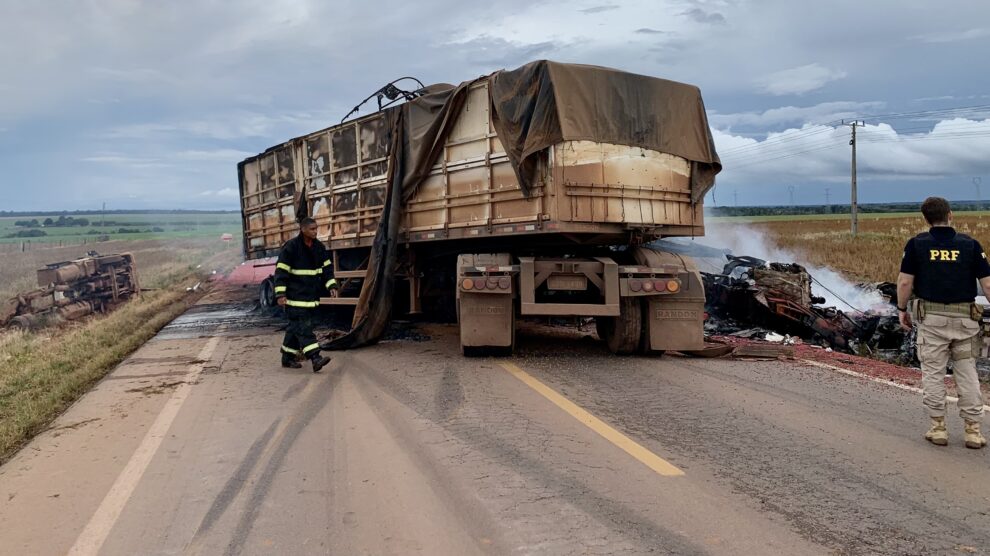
[{"left": 489, "top": 60, "right": 722, "bottom": 202}]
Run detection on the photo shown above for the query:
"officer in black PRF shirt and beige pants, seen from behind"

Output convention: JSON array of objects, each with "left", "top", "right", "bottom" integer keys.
[{"left": 897, "top": 197, "right": 990, "bottom": 448}]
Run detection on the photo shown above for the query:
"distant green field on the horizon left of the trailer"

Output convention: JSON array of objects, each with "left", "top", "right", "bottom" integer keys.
[{"left": 0, "top": 212, "right": 241, "bottom": 245}]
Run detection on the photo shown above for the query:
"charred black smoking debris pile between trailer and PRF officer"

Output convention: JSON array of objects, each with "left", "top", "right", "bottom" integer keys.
[{"left": 701, "top": 254, "right": 914, "bottom": 364}]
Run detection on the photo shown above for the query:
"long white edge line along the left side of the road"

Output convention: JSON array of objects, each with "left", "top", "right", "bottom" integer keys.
[{"left": 68, "top": 336, "right": 220, "bottom": 556}]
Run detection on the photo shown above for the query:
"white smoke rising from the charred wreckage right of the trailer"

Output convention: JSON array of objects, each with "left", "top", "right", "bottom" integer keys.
[{"left": 699, "top": 225, "right": 891, "bottom": 312}]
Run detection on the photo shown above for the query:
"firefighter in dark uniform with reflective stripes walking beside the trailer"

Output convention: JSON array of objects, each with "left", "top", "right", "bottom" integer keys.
[{"left": 275, "top": 217, "right": 337, "bottom": 373}]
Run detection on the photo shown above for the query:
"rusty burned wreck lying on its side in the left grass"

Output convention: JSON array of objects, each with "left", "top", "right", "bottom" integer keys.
[{"left": 0, "top": 251, "right": 140, "bottom": 328}]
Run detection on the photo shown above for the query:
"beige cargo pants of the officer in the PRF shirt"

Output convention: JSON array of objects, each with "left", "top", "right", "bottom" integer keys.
[{"left": 917, "top": 314, "right": 983, "bottom": 421}]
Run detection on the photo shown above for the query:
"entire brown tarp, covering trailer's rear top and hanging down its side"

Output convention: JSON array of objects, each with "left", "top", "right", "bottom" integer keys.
[{"left": 324, "top": 61, "right": 721, "bottom": 350}]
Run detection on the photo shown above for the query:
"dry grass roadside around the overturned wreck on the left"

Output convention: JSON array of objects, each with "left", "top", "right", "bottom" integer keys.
[{"left": 0, "top": 240, "right": 240, "bottom": 462}]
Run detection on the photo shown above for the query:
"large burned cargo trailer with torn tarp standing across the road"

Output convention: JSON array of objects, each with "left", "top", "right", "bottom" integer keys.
[{"left": 238, "top": 61, "right": 721, "bottom": 354}]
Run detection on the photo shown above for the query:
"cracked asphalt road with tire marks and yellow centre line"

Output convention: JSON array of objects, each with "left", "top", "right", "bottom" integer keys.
[{"left": 0, "top": 294, "right": 990, "bottom": 555}]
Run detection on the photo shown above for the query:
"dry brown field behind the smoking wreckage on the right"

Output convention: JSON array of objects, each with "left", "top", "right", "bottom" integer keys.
[{"left": 709, "top": 213, "right": 990, "bottom": 282}]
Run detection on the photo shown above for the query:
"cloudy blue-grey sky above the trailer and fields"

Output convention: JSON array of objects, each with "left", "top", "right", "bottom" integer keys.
[{"left": 0, "top": 0, "right": 990, "bottom": 210}]
